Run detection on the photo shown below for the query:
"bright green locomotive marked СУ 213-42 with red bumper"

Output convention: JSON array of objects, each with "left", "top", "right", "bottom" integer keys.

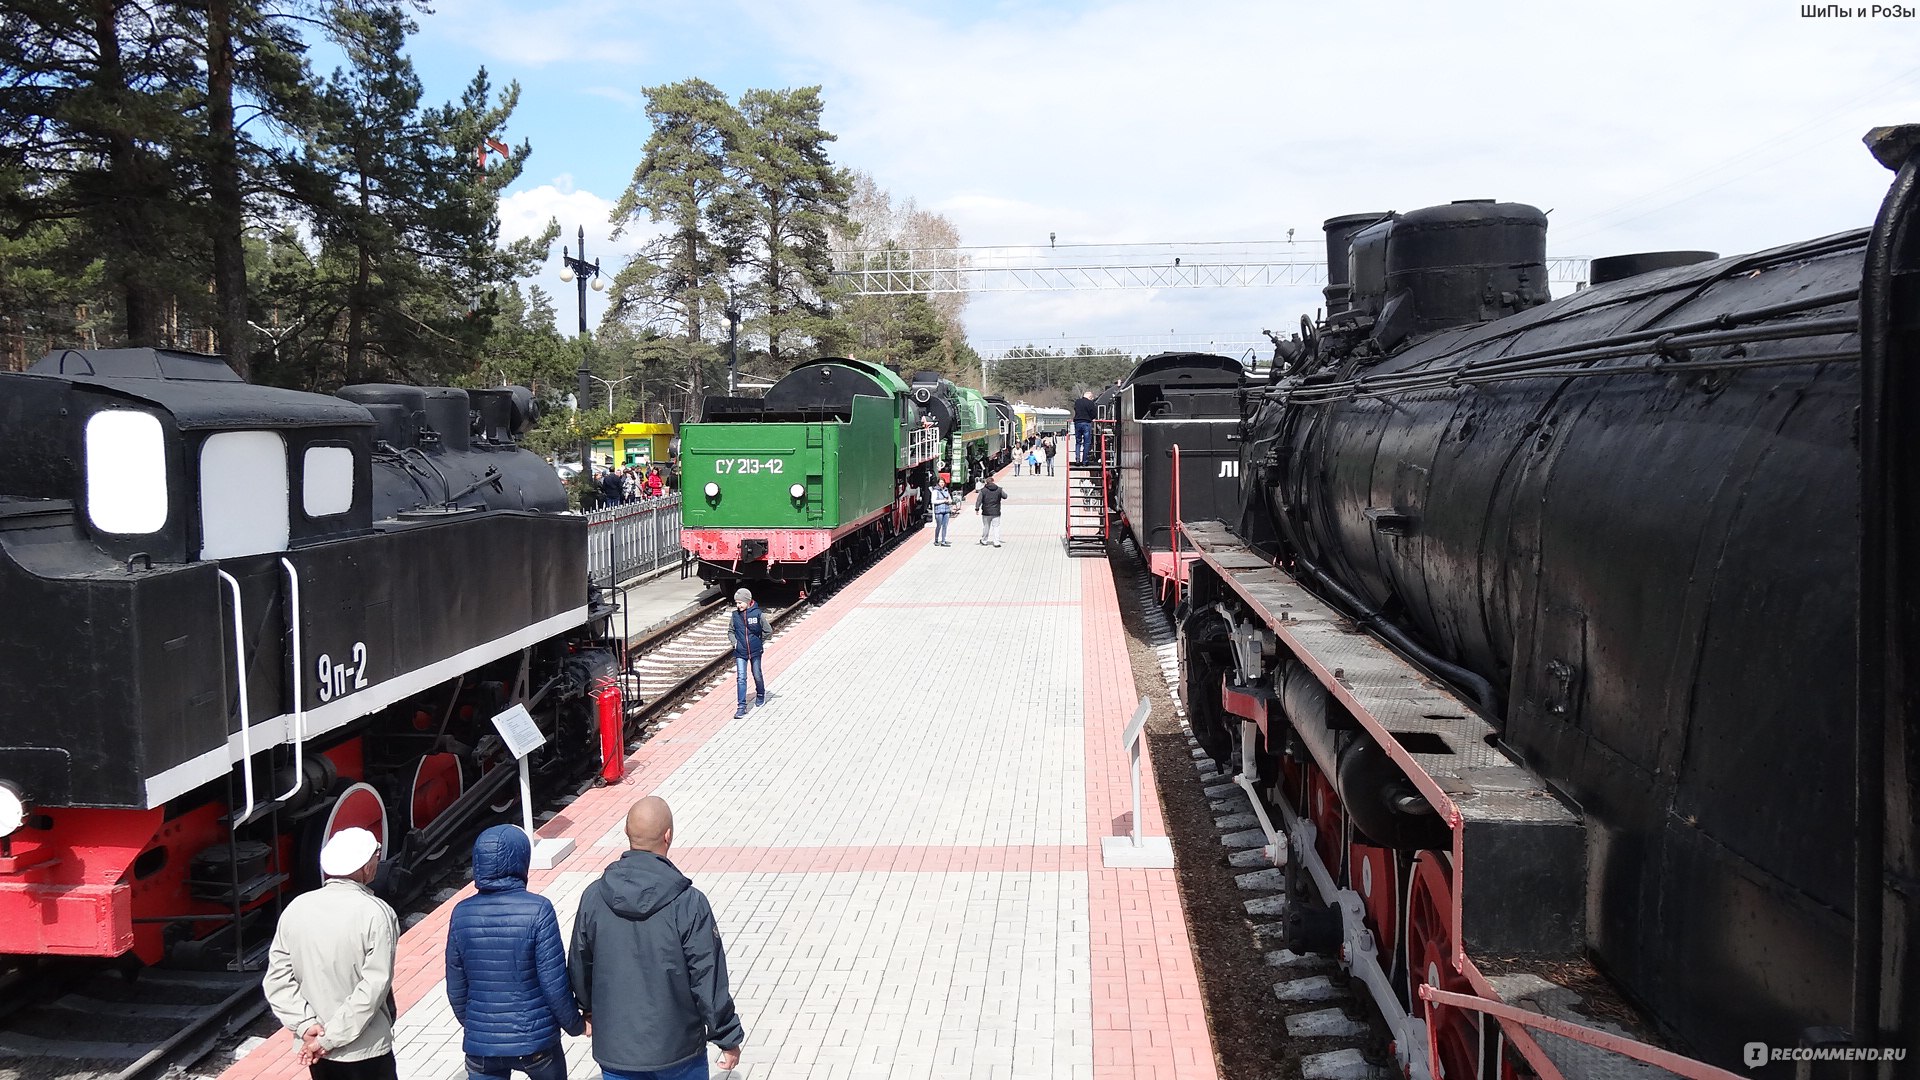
[{"left": 680, "top": 356, "right": 956, "bottom": 588}]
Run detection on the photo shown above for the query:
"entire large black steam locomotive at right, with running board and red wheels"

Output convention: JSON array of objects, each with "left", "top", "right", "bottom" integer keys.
[{"left": 1181, "top": 129, "right": 1920, "bottom": 1080}]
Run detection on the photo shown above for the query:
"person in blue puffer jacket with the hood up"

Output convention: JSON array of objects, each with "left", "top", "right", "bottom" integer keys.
[{"left": 447, "top": 824, "right": 586, "bottom": 1080}]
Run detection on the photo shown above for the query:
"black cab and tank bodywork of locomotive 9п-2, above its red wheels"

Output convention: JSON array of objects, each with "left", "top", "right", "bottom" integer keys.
[{"left": 0, "top": 350, "right": 589, "bottom": 807}]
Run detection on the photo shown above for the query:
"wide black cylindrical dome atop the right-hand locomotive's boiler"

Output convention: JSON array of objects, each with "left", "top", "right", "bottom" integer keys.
[{"left": 1375, "top": 200, "right": 1549, "bottom": 348}]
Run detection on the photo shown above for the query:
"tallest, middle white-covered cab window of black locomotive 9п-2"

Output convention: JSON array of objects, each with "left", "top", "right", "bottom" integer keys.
[{"left": 200, "top": 430, "right": 290, "bottom": 559}]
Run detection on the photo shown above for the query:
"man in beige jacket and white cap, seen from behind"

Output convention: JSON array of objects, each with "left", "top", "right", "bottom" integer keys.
[{"left": 261, "top": 828, "right": 399, "bottom": 1080}]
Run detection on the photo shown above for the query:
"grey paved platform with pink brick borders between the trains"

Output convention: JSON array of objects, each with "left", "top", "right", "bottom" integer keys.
[{"left": 227, "top": 469, "right": 1215, "bottom": 1080}]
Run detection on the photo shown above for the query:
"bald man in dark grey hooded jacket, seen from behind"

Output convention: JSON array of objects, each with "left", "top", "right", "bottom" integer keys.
[{"left": 566, "top": 796, "right": 747, "bottom": 1080}]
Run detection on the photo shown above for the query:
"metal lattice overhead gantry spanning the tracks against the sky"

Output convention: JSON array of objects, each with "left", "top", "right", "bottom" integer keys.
[{"left": 833, "top": 240, "right": 1588, "bottom": 296}]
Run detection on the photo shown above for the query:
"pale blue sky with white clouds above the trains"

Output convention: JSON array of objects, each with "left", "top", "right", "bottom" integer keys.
[{"left": 397, "top": 0, "right": 1920, "bottom": 344}]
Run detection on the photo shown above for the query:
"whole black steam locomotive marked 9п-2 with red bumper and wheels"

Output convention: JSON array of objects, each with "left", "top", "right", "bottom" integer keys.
[{"left": 0, "top": 350, "right": 624, "bottom": 963}]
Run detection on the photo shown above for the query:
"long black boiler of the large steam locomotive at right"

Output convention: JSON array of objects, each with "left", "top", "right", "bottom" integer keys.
[{"left": 1242, "top": 222, "right": 1864, "bottom": 1061}]
